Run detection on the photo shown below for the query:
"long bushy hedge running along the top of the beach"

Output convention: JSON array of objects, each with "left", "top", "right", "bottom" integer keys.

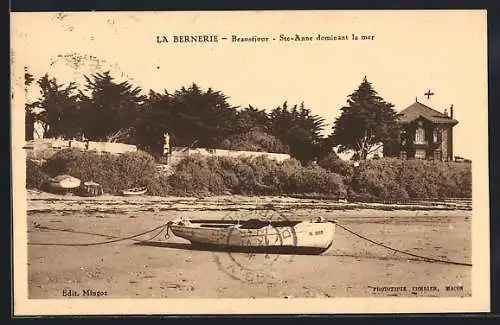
[{"left": 26, "top": 149, "right": 472, "bottom": 201}]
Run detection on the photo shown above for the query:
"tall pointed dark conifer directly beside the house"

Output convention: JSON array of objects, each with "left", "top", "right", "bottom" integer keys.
[{"left": 332, "top": 77, "right": 399, "bottom": 160}]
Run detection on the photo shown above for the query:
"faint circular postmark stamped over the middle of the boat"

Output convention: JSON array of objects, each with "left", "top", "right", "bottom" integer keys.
[{"left": 214, "top": 206, "right": 297, "bottom": 283}]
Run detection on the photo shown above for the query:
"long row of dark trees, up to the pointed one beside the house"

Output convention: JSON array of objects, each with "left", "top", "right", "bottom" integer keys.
[{"left": 25, "top": 70, "right": 397, "bottom": 164}]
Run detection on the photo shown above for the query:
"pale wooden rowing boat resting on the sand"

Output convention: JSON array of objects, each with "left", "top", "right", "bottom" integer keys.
[{"left": 170, "top": 218, "right": 335, "bottom": 254}]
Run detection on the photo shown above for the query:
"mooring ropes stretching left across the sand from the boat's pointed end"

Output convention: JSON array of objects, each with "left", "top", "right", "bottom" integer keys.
[{"left": 28, "top": 221, "right": 172, "bottom": 246}]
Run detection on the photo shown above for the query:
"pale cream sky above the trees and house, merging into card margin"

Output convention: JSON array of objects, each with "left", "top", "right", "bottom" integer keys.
[{"left": 11, "top": 10, "right": 488, "bottom": 159}]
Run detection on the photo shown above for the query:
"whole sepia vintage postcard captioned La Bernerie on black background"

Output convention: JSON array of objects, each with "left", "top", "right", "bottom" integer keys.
[{"left": 11, "top": 10, "right": 490, "bottom": 315}]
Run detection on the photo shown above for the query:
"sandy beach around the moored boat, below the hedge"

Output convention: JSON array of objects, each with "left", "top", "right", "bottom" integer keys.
[{"left": 28, "top": 191, "right": 471, "bottom": 299}]
